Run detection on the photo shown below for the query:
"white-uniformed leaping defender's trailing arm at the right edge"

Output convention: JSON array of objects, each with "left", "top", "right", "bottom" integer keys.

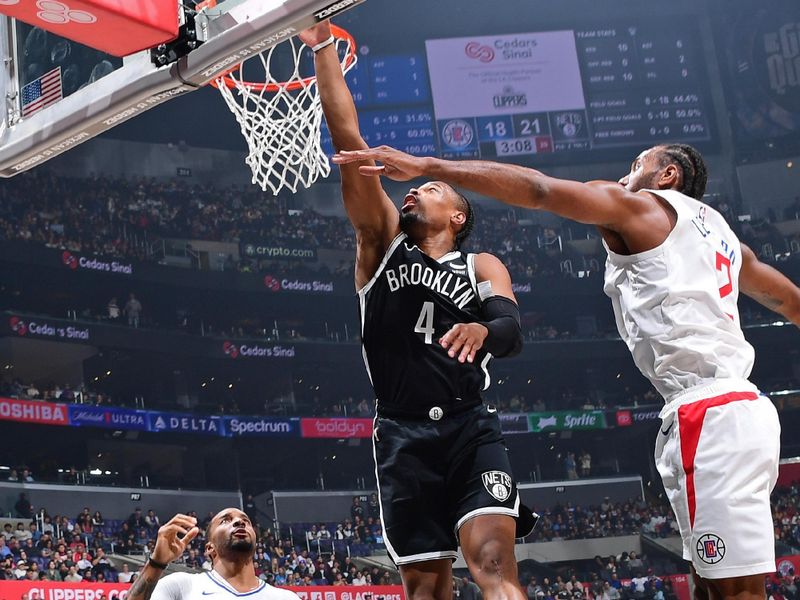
[{"left": 739, "top": 244, "right": 800, "bottom": 327}]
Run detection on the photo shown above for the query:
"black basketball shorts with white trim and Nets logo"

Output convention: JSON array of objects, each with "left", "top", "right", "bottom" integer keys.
[{"left": 372, "top": 405, "right": 520, "bottom": 565}]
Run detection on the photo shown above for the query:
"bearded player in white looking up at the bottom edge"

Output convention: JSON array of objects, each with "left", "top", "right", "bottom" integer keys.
[{"left": 126, "top": 508, "right": 299, "bottom": 600}]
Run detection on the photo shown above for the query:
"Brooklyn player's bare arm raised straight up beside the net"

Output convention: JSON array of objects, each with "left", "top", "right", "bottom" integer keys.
[{"left": 299, "top": 21, "right": 400, "bottom": 287}]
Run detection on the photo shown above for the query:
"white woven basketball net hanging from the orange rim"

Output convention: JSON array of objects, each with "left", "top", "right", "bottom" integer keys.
[{"left": 216, "top": 38, "right": 357, "bottom": 196}]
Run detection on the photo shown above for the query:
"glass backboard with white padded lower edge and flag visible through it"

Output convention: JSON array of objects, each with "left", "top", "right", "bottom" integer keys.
[{"left": 0, "top": 0, "right": 364, "bottom": 177}]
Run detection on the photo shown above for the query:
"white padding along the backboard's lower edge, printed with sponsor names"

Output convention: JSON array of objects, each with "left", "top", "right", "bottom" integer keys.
[{"left": 0, "top": 0, "right": 364, "bottom": 177}]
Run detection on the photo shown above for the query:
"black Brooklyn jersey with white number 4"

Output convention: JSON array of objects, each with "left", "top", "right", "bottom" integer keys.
[{"left": 358, "top": 233, "right": 491, "bottom": 417}]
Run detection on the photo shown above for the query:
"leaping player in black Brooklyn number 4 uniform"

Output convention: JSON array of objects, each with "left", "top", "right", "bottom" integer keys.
[{"left": 300, "top": 23, "right": 533, "bottom": 600}]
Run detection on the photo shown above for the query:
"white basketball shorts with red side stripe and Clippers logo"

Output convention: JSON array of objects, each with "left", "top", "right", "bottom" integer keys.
[{"left": 655, "top": 391, "right": 780, "bottom": 579}]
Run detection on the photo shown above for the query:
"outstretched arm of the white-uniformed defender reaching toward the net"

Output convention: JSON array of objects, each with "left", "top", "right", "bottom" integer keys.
[{"left": 334, "top": 146, "right": 659, "bottom": 233}]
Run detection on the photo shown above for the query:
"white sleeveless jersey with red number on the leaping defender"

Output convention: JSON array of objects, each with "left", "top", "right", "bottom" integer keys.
[{"left": 603, "top": 190, "right": 754, "bottom": 402}]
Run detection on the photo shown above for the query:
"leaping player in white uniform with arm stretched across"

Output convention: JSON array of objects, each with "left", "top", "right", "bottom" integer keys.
[{"left": 334, "top": 144, "right": 800, "bottom": 600}]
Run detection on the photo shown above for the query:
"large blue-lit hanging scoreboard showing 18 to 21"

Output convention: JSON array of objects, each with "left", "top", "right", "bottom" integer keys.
[{"left": 323, "top": 17, "right": 713, "bottom": 159}]
